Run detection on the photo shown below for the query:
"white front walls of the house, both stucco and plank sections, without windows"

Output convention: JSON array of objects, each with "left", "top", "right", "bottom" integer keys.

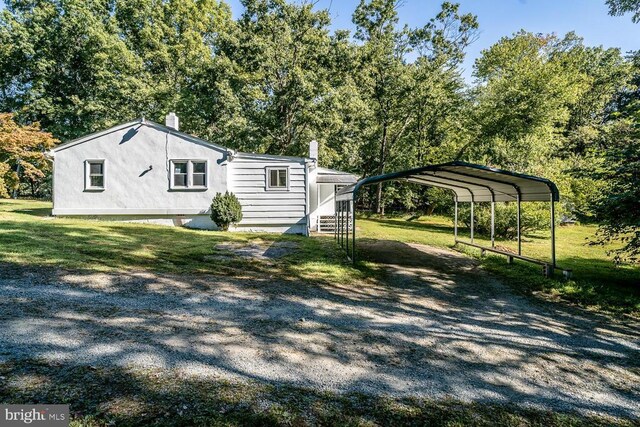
[{"left": 53, "top": 122, "right": 309, "bottom": 234}]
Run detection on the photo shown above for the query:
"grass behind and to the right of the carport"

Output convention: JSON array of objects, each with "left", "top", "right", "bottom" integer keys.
[{"left": 358, "top": 216, "right": 640, "bottom": 317}]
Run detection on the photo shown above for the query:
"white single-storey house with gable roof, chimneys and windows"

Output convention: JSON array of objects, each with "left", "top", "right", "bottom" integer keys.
[{"left": 51, "top": 113, "right": 357, "bottom": 234}]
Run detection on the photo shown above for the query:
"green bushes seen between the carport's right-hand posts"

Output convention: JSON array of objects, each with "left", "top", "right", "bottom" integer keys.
[{"left": 459, "top": 202, "right": 559, "bottom": 239}]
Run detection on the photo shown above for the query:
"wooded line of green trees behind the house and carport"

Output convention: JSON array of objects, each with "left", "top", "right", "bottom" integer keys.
[{"left": 0, "top": 0, "right": 640, "bottom": 256}]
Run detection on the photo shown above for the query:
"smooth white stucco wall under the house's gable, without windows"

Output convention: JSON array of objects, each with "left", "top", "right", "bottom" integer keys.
[{"left": 53, "top": 123, "right": 228, "bottom": 228}]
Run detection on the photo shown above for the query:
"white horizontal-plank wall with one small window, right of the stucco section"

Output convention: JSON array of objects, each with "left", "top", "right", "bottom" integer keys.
[{"left": 229, "top": 154, "right": 307, "bottom": 234}]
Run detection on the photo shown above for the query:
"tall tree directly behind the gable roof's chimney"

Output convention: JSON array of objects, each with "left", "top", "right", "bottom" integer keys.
[{"left": 115, "top": 0, "right": 234, "bottom": 136}]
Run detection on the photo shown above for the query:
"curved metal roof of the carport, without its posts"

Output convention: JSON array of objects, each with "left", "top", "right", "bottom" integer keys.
[{"left": 336, "top": 161, "right": 560, "bottom": 206}]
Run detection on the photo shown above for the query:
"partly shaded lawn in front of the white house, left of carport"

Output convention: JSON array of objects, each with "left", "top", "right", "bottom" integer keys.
[{"left": 0, "top": 200, "right": 361, "bottom": 286}]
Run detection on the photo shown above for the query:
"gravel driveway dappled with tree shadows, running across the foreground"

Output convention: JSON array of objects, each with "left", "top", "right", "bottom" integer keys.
[{"left": 0, "top": 242, "right": 640, "bottom": 418}]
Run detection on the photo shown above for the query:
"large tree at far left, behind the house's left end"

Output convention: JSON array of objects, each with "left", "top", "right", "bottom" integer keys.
[{"left": 0, "top": 0, "right": 144, "bottom": 138}]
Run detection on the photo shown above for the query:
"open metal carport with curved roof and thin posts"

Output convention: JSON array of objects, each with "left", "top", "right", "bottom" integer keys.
[{"left": 335, "top": 161, "right": 560, "bottom": 275}]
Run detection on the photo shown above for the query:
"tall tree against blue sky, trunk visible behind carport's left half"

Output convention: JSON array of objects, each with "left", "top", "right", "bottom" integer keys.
[{"left": 353, "top": 0, "right": 478, "bottom": 214}]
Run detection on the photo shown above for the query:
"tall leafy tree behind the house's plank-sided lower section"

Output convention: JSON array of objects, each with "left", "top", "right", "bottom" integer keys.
[{"left": 226, "top": 0, "right": 331, "bottom": 155}]
